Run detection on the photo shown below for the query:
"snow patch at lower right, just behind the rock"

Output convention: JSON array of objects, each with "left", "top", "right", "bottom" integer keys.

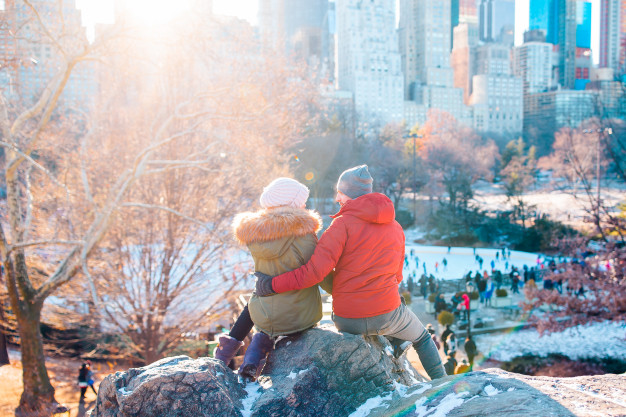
[{"left": 475, "top": 322, "right": 626, "bottom": 361}]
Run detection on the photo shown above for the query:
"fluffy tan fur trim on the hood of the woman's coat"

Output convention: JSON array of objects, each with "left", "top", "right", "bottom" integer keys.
[{"left": 233, "top": 207, "right": 322, "bottom": 245}]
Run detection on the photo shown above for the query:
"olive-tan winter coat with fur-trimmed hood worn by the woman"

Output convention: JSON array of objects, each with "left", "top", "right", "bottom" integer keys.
[{"left": 233, "top": 207, "right": 322, "bottom": 336}]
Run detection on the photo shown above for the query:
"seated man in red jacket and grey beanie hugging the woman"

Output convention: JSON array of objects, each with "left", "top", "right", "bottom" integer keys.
[{"left": 255, "top": 165, "right": 446, "bottom": 379}]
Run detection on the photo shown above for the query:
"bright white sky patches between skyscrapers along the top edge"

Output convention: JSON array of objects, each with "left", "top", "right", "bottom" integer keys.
[{"left": 76, "top": 0, "right": 600, "bottom": 64}]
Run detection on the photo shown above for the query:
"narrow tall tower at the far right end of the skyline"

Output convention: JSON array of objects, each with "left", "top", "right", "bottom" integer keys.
[{"left": 600, "top": 0, "right": 626, "bottom": 75}]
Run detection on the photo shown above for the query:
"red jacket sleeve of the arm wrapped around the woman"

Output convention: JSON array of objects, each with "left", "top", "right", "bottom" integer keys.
[{"left": 272, "top": 217, "right": 348, "bottom": 293}]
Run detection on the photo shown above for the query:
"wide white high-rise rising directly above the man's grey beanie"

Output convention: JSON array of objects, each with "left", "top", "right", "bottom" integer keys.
[{"left": 335, "top": 0, "right": 404, "bottom": 123}]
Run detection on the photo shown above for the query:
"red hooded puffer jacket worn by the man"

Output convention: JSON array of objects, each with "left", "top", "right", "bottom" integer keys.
[{"left": 272, "top": 193, "right": 404, "bottom": 318}]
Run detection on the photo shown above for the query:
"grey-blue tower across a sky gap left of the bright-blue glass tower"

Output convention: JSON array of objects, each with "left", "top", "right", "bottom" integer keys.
[{"left": 478, "top": 0, "right": 515, "bottom": 45}]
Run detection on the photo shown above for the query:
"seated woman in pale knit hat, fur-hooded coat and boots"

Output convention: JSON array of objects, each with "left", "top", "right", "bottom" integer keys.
[{"left": 215, "top": 177, "right": 322, "bottom": 379}]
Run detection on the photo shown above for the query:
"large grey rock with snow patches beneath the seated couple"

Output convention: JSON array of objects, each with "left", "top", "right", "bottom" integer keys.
[{"left": 91, "top": 327, "right": 626, "bottom": 417}]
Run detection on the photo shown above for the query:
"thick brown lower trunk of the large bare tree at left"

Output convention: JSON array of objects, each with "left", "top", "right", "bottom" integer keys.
[{"left": 16, "top": 305, "right": 55, "bottom": 416}]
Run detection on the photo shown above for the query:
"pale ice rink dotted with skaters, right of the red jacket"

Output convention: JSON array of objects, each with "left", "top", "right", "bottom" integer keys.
[{"left": 403, "top": 240, "right": 545, "bottom": 279}]
